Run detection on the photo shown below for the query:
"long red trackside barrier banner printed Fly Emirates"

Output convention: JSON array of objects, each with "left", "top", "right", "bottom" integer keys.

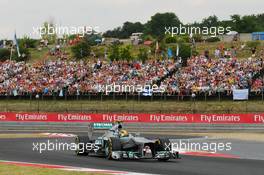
[{"left": 0, "top": 112, "right": 264, "bottom": 124}]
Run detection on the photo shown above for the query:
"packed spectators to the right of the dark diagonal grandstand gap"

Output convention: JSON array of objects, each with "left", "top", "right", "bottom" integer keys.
[{"left": 163, "top": 55, "right": 263, "bottom": 95}]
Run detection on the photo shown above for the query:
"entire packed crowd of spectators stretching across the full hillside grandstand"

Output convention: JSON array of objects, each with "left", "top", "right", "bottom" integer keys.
[{"left": 0, "top": 51, "right": 264, "bottom": 96}]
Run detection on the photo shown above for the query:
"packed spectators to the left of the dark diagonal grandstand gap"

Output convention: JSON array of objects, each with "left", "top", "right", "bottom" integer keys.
[{"left": 0, "top": 60, "right": 174, "bottom": 96}]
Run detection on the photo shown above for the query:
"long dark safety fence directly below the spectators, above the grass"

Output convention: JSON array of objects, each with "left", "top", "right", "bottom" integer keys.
[{"left": 0, "top": 90, "right": 264, "bottom": 101}]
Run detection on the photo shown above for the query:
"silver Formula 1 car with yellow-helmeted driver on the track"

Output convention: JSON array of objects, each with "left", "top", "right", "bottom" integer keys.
[{"left": 75, "top": 122, "right": 179, "bottom": 161}]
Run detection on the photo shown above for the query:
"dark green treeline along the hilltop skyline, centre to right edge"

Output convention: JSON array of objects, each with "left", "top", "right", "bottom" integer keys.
[{"left": 104, "top": 13, "right": 264, "bottom": 39}]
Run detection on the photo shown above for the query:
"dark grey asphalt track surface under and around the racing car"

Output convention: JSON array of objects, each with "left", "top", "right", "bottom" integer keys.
[{"left": 0, "top": 138, "right": 264, "bottom": 175}]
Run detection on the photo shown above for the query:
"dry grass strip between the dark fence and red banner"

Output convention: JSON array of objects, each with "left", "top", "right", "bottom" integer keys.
[{"left": 0, "top": 100, "right": 264, "bottom": 113}]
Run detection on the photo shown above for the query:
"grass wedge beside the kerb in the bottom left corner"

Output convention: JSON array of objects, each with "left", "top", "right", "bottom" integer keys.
[{"left": 0, "top": 164, "right": 105, "bottom": 175}]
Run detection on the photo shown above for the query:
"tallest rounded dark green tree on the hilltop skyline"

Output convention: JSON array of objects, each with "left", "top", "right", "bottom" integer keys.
[{"left": 145, "top": 12, "right": 181, "bottom": 38}]
